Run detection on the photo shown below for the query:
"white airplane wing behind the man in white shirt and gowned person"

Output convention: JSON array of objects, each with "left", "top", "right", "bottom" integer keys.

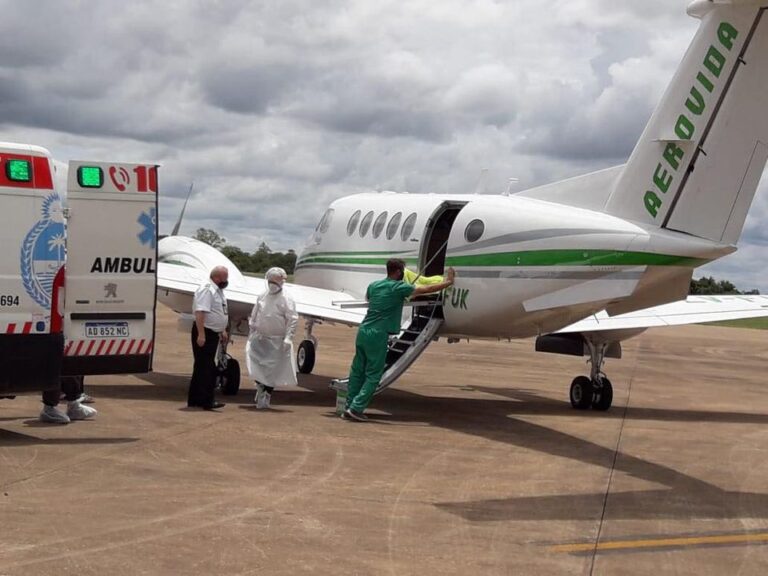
[{"left": 157, "top": 262, "right": 367, "bottom": 326}]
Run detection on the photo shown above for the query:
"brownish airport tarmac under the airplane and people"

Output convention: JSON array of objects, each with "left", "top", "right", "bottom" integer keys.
[{"left": 0, "top": 309, "right": 768, "bottom": 576}]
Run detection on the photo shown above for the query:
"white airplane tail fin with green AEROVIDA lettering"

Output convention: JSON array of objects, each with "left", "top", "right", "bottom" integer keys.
[{"left": 605, "top": 0, "right": 768, "bottom": 244}]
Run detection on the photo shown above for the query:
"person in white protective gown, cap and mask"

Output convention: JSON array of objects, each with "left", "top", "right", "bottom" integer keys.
[{"left": 245, "top": 268, "right": 299, "bottom": 410}]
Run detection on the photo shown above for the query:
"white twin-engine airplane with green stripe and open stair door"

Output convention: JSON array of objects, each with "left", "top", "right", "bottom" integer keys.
[{"left": 153, "top": 0, "right": 768, "bottom": 410}]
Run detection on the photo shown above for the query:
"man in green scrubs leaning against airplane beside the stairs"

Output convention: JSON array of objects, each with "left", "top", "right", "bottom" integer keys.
[{"left": 342, "top": 258, "right": 456, "bottom": 422}]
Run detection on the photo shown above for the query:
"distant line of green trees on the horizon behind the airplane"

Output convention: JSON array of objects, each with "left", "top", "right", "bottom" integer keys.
[{"left": 195, "top": 228, "right": 760, "bottom": 295}]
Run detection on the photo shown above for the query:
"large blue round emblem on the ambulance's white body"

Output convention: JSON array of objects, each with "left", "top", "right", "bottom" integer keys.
[{"left": 21, "top": 192, "right": 67, "bottom": 309}]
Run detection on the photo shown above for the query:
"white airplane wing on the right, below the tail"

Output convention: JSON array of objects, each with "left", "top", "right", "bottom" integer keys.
[{"left": 556, "top": 296, "right": 768, "bottom": 334}]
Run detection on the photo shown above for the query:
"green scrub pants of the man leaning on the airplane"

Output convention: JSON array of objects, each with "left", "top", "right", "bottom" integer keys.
[{"left": 347, "top": 328, "right": 388, "bottom": 412}]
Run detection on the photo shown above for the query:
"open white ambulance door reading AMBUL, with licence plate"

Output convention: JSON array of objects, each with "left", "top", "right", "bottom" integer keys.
[{"left": 62, "top": 162, "right": 157, "bottom": 375}]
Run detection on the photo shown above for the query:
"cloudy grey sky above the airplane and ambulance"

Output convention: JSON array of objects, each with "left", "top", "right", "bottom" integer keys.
[{"left": 0, "top": 0, "right": 768, "bottom": 292}]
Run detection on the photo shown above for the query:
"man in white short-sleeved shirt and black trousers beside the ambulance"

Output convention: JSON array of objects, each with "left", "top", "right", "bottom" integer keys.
[{"left": 187, "top": 266, "right": 229, "bottom": 410}]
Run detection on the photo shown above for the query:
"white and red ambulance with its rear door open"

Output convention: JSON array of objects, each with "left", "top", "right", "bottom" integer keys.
[{"left": 0, "top": 143, "right": 158, "bottom": 396}]
